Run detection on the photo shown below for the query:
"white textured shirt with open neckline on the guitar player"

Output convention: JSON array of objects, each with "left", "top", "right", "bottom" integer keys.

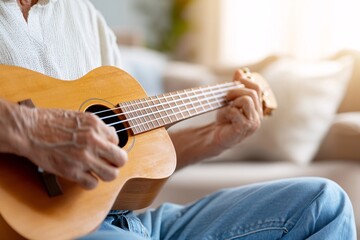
[{"left": 0, "top": 0, "right": 121, "bottom": 80}]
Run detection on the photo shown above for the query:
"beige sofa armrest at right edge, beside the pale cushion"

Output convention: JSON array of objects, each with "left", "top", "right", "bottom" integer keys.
[{"left": 315, "top": 112, "right": 360, "bottom": 162}]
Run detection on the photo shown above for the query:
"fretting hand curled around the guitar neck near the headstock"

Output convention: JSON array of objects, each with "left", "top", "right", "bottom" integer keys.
[{"left": 214, "top": 70, "right": 263, "bottom": 149}]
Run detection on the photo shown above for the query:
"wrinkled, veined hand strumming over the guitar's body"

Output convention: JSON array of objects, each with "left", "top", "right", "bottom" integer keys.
[{"left": 16, "top": 107, "right": 127, "bottom": 189}]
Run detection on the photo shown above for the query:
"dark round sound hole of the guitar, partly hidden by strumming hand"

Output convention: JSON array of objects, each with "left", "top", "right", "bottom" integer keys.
[{"left": 86, "top": 105, "right": 129, "bottom": 147}]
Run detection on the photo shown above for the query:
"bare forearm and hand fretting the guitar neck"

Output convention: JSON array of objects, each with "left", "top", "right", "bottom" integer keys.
[{"left": 170, "top": 70, "right": 263, "bottom": 169}]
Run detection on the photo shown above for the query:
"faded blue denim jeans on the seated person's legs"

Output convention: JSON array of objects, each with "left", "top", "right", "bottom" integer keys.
[{"left": 82, "top": 178, "right": 356, "bottom": 240}]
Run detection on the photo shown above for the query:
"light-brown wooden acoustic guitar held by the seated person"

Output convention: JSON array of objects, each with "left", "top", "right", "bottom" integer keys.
[{"left": 0, "top": 65, "right": 276, "bottom": 240}]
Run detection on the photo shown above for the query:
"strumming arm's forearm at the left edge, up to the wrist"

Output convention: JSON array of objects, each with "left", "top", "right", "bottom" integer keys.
[{"left": 0, "top": 99, "right": 22, "bottom": 154}]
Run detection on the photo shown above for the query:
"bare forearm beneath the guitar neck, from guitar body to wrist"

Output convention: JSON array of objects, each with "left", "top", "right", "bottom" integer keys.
[{"left": 169, "top": 124, "right": 224, "bottom": 169}]
